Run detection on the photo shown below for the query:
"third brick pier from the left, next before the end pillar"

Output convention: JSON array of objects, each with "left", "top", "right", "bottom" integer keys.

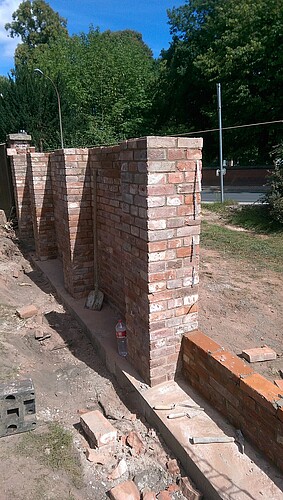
[{"left": 51, "top": 149, "right": 93, "bottom": 298}]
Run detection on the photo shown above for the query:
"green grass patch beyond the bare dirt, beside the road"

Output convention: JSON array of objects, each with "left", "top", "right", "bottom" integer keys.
[{"left": 201, "top": 204, "right": 283, "bottom": 272}]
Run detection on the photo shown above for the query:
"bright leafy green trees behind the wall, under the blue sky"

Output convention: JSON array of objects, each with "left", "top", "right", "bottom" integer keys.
[{"left": 0, "top": 0, "right": 154, "bottom": 150}]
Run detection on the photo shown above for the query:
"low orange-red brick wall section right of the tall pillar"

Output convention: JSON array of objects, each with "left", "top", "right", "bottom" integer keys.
[{"left": 182, "top": 331, "right": 283, "bottom": 470}]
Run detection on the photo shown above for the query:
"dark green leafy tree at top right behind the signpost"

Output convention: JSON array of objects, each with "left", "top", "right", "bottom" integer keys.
[{"left": 155, "top": 0, "right": 283, "bottom": 160}]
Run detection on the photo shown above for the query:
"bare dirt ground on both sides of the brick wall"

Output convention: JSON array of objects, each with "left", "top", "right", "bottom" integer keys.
[{"left": 0, "top": 212, "right": 283, "bottom": 500}]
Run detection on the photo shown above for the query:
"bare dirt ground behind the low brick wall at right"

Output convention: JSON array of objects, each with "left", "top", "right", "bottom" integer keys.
[{"left": 199, "top": 214, "right": 283, "bottom": 381}]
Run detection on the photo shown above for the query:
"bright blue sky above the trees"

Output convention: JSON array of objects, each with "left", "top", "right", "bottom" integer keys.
[{"left": 0, "top": 0, "right": 185, "bottom": 76}]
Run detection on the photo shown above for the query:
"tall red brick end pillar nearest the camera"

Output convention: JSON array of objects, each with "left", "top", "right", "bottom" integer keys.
[{"left": 121, "top": 137, "right": 202, "bottom": 385}]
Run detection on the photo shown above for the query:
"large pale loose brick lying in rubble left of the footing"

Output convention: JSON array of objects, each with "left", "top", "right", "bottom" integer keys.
[{"left": 80, "top": 410, "right": 117, "bottom": 448}]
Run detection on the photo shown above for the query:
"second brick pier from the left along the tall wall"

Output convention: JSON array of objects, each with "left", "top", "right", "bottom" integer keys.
[{"left": 27, "top": 153, "right": 57, "bottom": 260}]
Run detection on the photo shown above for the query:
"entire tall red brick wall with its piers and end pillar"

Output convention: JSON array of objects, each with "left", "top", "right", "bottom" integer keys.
[{"left": 8, "top": 137, "right": 202, "bottom": 385}]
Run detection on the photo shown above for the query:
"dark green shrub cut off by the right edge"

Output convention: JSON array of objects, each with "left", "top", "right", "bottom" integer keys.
[{"left": 266, "top": 143, "right": 283, "bottom": 224}]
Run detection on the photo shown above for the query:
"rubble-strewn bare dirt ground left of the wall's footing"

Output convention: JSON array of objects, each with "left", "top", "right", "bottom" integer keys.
[{"left": 0, "top": 232, "right": 189, "bottom": 500}]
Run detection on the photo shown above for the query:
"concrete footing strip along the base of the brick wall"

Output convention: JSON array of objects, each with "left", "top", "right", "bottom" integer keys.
[{"left": 31, "top": 260, "right": 283, "bottom": 500}]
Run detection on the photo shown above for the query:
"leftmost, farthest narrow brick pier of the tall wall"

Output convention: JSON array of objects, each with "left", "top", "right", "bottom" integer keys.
[{"left": 7, "top": 149, "right": 34, "bottom": 243}]
